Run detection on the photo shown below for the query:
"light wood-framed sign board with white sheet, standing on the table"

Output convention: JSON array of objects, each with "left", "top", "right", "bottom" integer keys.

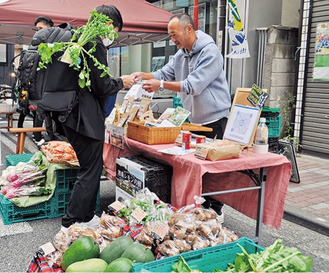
[{"left": 223, "top": 88, "right": 267, "bottom": 147}]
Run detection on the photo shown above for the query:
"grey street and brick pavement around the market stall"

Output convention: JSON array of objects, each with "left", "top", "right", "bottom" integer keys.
[{"left": 0, "top": 113, "right": 329, "bottom": 272}]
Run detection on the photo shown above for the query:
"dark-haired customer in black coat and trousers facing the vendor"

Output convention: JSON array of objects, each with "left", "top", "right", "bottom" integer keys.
[{"left": 61, "top": 5, "right": 134, "bottom": 228}]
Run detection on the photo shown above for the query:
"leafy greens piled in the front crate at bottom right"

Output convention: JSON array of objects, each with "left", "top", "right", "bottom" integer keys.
[{"left": 220, "top": 239, "right": 313, "bottom": 272}]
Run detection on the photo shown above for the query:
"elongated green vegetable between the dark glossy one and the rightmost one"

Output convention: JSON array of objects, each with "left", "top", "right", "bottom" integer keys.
[{"left": 99, "top": 236, "right": 134, "bottom": 263}]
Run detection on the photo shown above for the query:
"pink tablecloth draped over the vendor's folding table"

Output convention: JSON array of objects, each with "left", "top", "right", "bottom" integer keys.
[{"left": 103, "top": 138, "right": 291, "bottom": 228}]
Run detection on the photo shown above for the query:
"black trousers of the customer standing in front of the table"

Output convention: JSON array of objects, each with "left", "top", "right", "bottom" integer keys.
[{"left": 62, "top": 126, "right": 104, "bottom": 227}]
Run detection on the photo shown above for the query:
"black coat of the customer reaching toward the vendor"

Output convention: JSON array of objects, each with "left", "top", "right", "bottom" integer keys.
[{"left": 64, "top": 39, "right": 123, "bottom": 140}]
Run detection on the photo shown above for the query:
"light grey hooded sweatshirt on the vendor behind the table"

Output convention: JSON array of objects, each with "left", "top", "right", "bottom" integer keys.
[{"left": 153, "top": 30, "right": 231, "bottom": 124}]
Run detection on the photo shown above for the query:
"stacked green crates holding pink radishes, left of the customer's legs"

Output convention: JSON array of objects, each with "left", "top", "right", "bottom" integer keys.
[{"left": 0, "top": 154, "right": 100, "bottom": 225}]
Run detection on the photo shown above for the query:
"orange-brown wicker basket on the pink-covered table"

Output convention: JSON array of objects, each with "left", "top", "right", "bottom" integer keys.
[{"left": 127, "top": 121, "right": 181, "bottom": 144}]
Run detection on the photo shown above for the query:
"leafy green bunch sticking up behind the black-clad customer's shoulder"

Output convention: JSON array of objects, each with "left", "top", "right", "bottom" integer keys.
[{"left": 38, "top": 10, "right": 118, "bottom": 90}]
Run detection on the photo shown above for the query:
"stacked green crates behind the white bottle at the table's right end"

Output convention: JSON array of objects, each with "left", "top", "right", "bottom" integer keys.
[{"left": 261, "top": 107, "right": 281, "bottom": 152}]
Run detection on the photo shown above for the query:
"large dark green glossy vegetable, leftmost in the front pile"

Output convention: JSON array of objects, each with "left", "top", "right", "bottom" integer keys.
[{"left": 61, "top": 236, "right": 99, "bottom": 270}]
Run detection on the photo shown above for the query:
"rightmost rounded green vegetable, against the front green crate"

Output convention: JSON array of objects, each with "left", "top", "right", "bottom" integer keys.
[{"left": 121, "top": 243, "right": 154, "bottom": 263}]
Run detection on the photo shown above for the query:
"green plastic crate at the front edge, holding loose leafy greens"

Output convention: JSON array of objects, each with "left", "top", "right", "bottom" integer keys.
[{"left": 133, "top": 237, "right": 264, "bottom": 272}]
